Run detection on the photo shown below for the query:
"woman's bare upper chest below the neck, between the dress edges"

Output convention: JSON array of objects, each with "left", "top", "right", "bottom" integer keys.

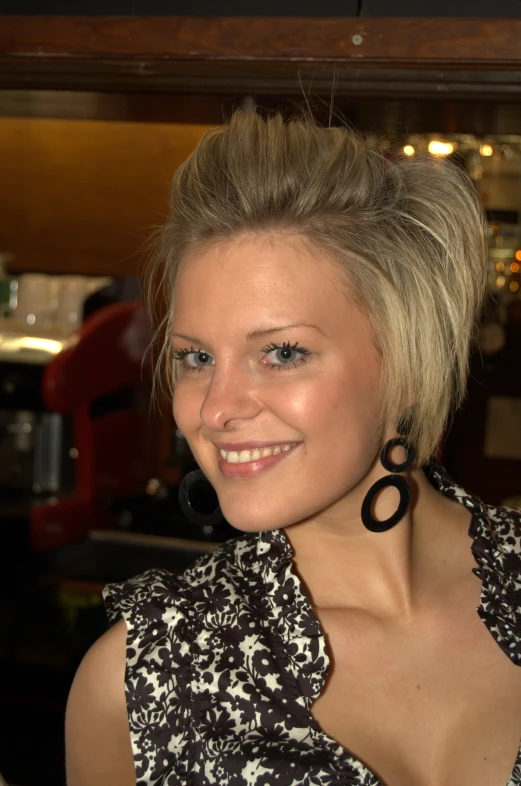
[{"left": 312, "top": 606, "right": 521, "bottom": 786}]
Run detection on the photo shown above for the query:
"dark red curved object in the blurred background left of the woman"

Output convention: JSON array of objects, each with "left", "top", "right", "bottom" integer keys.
[{"left": 31, "top": 302, "right": 154, "bottom": 549}]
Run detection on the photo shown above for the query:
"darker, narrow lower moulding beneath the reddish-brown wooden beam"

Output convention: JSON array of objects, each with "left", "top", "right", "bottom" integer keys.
[{"left": 0, "top": 61, "right": 521, "bottom": 99}]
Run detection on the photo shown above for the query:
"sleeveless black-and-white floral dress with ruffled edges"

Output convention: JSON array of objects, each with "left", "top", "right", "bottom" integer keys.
[{"left": 104, "top": 462, "right": 521, "bottom": 786}]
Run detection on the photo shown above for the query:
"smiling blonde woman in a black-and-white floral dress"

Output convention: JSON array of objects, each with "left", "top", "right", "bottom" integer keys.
[{"left": 67, "top": 111, "right": 521, "bottom": 786}]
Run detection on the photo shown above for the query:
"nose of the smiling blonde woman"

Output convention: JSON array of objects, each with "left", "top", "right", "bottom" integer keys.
[{"left": 200, "top": 366, "right": 262, "bottom": 431}]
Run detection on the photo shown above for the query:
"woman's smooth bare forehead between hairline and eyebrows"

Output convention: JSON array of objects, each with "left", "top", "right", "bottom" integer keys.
[{"left": 174, "top": 235, "right": 349, "bottom": 324}]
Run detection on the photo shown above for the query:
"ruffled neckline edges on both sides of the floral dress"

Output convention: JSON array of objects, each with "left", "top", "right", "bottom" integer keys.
[{"left": 244, "top": 460, "right": 521, "bottom": 704}]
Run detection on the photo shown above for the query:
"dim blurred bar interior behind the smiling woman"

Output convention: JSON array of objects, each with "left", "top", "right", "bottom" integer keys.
[{"left": 0, "top": 0, "right": 521, "bottom": 786}]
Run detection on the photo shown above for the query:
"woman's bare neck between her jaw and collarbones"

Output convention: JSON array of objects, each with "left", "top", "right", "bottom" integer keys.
[{"left": 286, "top": 462, "right": 470, "bottom": 618}]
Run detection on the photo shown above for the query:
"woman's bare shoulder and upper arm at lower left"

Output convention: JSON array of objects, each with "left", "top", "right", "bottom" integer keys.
[{"left": 65, "top": 620, "right": 136, "bottom": 786}]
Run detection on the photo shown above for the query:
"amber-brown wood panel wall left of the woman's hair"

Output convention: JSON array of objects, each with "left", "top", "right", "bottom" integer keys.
[{"left": 0, "top": 115, "right": 213, "bottom": 275}]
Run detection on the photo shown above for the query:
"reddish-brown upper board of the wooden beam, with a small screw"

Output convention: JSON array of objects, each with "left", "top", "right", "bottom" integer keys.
[{"left": 0, "top": 16, "right": 521, "bottom": 68}]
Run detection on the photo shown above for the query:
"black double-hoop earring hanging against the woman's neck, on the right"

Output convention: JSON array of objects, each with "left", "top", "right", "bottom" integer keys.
[{"left": 362, "top": 437, "right": 415, "bottom": 532}]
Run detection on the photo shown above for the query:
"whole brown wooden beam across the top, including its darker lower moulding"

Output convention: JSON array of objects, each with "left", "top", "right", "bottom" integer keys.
[{"left": 0, "top": 16, "right": 521, "bottom": 101}]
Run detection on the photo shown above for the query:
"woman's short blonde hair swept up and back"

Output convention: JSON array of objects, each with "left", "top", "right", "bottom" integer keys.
[{"left": 149, "top": 110, "right": 486, "bottom": 464}]
